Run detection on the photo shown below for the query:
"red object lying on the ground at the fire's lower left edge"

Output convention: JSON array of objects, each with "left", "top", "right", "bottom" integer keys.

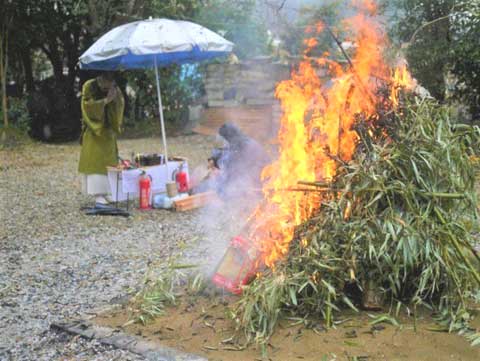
[{"left": 212, "top": 236, "right": 259, "bottom": 295}]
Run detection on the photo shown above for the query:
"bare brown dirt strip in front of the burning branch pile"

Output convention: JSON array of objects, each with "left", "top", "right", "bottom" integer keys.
[{"left": 96, "top": 292, "right": 480, "bottom": 361}]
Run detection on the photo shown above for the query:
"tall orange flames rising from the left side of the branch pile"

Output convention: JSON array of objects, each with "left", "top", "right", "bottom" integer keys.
[{"left": 249, "top": 0, "right": 412, "bottom": 267}]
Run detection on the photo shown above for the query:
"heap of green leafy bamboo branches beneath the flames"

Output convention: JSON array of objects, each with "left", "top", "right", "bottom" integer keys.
[{"left": 235, "top": 95, "right": 480, "bottom": 345}]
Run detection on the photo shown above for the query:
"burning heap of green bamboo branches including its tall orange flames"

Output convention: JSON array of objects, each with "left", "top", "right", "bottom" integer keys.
[{"left": 231, "top": 1, "right": 480, "bottom": 344}]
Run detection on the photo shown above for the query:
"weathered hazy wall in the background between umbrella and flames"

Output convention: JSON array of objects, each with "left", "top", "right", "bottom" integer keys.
[{"left": 194, "top": 58, "right": 290, "bottom": 143}]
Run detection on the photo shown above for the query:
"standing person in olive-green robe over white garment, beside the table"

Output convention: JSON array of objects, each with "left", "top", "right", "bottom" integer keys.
[{"left": 78, "top": 72, "right": 125, "bottom": 207}]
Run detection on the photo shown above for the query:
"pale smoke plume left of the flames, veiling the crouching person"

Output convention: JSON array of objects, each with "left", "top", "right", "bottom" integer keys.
[{"left": 192, "top": 122, "right": 270, "bottom": 277}]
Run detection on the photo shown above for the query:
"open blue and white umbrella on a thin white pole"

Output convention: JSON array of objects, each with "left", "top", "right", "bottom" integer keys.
[{"left": 79, "top": 19, "right": 233, "bottom": 165}]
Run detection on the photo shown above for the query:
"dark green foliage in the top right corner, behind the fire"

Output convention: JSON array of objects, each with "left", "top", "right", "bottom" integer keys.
[{"left": 391, "top": 0, "right": 480, "bottom": 118}]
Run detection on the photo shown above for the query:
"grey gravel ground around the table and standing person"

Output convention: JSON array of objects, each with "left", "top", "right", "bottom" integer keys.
[{"left": 0, "top": 135, "right": 213, "bottom": 361}]
